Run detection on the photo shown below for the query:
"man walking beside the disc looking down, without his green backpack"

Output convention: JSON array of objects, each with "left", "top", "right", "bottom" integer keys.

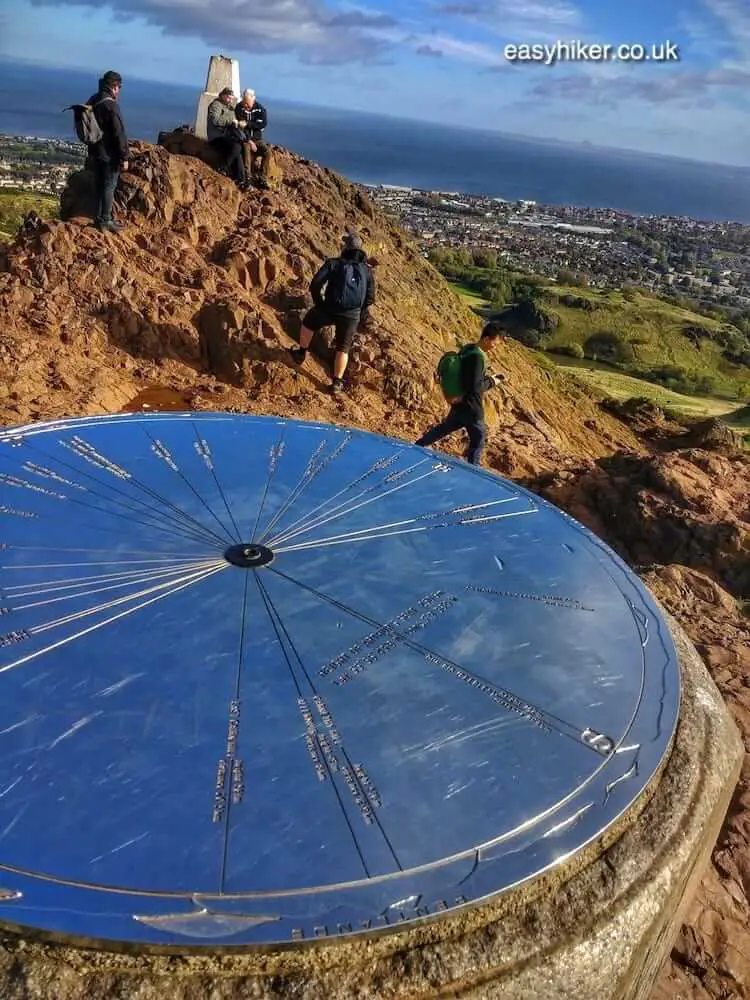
[{"left": 415, "top": 319, "right": 508, "bottom": 465}]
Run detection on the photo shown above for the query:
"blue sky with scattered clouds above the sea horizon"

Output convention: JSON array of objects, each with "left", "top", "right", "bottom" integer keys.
[{"left": 0, "top": 0, "right": 750, "bottom": 166}]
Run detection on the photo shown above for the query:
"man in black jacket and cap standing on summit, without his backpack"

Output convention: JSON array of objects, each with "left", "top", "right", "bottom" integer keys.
[{"left": 87, "top": 70, "right": 128, "bottom": 233}]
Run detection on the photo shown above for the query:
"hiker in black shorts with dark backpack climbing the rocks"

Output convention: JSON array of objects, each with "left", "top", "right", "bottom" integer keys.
[{"left": 289, "top": 233, "right": 375, "bottom": 395}]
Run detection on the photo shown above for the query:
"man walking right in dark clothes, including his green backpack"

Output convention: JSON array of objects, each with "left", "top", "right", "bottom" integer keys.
[{"left": 415, "top": 306, "right": 519, "bottom": 465}]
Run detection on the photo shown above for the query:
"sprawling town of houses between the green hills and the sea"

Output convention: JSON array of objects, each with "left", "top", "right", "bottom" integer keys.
[{"left": 0, "top": 136, "right": 750, "bottom": 311}]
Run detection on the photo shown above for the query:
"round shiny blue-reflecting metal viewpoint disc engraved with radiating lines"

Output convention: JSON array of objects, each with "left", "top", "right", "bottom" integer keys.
[{"left": 0, "top": 413, "right": 679, "bottom": 948}]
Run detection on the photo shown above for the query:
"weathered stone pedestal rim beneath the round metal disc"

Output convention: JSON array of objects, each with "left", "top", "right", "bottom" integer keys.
[{"left": 0, "top": 621, "right": 742, "bottom": 1000}]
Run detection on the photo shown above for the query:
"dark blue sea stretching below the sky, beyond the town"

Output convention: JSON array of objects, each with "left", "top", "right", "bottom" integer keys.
[{"left": 0, "top": 60, "right": 750, "bottom": 224}]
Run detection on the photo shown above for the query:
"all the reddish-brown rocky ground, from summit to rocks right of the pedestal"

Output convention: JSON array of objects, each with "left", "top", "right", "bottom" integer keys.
[{"left": 0, "top": 144, "right": 750, "bottom": 1000}]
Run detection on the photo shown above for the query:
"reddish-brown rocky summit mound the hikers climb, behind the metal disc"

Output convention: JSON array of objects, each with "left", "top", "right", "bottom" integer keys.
[{"left": 0, "top": 145, "right": 638, "bottom": 474}]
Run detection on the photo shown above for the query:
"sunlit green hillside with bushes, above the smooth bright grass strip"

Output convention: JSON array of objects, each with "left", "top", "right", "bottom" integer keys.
[{"left": 548, "top": 285, "right": 750, "bottom": 396}]
